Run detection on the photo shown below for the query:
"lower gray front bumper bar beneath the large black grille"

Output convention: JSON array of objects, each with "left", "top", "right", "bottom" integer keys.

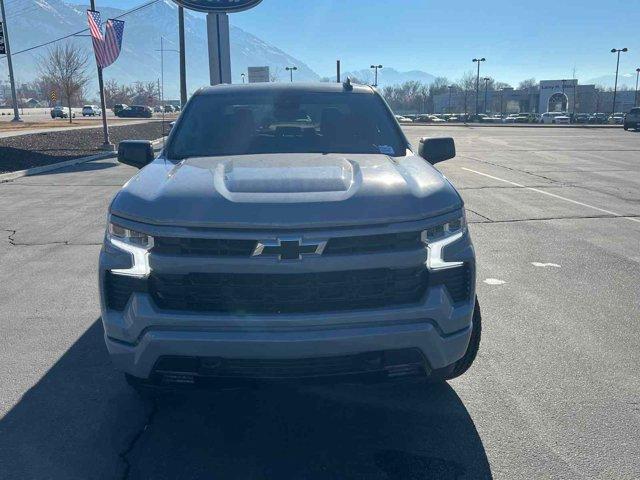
[{"left": 102, "top": 288, "right": 473, "bottom": 378}]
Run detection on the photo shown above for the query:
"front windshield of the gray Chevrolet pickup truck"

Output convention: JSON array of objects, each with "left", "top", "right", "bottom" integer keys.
[{"left": 168, "top": 92, "right": 406, "bottom": 159}]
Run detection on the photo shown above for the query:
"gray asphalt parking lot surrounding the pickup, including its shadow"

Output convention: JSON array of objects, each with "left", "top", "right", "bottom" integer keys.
[{"left": 0, "top": 126, "right": 640, "bottom": 480}]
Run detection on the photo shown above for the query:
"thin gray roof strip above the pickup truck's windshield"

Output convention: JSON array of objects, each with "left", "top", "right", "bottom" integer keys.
[{"left": 196, "top": 82, "right": 374, "bottom": 95}]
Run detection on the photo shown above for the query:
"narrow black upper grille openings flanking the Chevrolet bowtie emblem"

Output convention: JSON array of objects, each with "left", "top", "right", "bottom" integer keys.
[{"left": 153, "top": 232, "right": 423, "bottom": 258}]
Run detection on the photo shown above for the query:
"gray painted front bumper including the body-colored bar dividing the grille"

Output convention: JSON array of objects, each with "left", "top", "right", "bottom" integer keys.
[{"left": 99, "top": 216, "right": 475, "bottom": 378}]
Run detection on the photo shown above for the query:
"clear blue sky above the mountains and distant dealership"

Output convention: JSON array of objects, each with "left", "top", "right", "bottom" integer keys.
[{"left": 96, "top": 0, "right": 640, "bottom": 83}]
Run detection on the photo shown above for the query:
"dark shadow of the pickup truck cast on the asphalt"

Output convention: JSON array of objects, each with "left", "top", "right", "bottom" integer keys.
[{"left": 0, "top": 320, "right": 492, "bottom": 480}]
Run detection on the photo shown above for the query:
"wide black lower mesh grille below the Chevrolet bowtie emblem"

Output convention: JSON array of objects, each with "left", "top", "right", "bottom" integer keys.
[{"left": 149, "top": 267, "right": 428, "bottom": 314}]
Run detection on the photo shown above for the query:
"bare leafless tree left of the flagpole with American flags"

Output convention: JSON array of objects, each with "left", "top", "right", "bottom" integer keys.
[{"left": 39, "top": 43, "right": 89, "bottom": 123}]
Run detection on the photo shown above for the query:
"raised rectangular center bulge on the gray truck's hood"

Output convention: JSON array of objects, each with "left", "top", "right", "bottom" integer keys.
[{"left": 223, "top": 155, "right": 353, "bottom": 193}]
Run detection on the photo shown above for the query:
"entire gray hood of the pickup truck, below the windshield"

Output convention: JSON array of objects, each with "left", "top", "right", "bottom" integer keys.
[{"left": 111, "top": 154, "right": 462, "bottom": 228}]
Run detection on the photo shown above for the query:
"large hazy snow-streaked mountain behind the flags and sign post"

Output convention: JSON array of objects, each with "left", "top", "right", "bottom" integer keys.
[{"left": 0, "top": 0, "right": 319, "bottom": 98}]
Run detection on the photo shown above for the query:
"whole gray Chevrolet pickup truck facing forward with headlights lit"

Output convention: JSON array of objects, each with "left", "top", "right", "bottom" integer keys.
[{"left": 99, "top": 81, "right": 481, "bottom": 390}]
